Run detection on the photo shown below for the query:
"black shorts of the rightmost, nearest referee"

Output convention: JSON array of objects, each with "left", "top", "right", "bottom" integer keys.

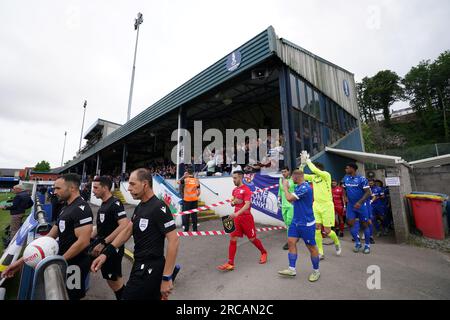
[{"left": 122, "top": 256, "right": 166, "bottom": 300}]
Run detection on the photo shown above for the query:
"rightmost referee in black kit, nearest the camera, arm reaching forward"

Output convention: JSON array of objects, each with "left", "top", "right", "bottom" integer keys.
[{"left": 91, "top": 168, "right": 179, "bottom": 300}]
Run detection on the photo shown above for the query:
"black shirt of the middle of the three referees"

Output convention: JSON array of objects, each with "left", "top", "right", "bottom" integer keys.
[{"left": 97, "top": 197, "right": 127, "bottom": 239}]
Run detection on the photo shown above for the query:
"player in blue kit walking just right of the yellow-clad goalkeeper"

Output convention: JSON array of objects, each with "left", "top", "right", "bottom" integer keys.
[{"left": 343, "top": 162, "right": 371, "bottom": 254}]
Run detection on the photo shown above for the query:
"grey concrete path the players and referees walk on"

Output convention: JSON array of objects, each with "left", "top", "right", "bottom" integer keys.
[{"left": 87, "top": 206, "right": 450, "bottom": 300}]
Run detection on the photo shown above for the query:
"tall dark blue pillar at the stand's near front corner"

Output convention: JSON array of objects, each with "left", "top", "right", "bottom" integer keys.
[{"left": 278, "top": 66, "right": 297, "bottom": 170}]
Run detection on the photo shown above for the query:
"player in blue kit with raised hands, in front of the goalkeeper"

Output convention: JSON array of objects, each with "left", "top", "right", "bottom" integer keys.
[{"left": 278, "top": 170, "right": 320, "bottom": 282}]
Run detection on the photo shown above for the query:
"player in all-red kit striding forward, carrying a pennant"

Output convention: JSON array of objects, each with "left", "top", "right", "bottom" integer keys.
[{"left": 217, "top": 171, "right": 267, "bottom": 271}]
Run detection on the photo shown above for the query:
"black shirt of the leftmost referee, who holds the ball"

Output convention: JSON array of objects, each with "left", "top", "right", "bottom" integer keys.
[{"left": 57, "top": 197, "right": 93, "bottom": 255}]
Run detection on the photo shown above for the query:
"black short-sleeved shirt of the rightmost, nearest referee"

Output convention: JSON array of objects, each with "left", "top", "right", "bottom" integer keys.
[{"left": 131, "top": 196, "right": 176, "bottom": 261}]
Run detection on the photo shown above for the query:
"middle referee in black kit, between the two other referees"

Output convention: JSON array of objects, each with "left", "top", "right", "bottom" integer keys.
[{"left": 90, "top": 176, "right": 129, "bottom": 300}]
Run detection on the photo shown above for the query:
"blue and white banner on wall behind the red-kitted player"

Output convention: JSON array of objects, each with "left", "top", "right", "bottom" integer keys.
[{"left": 244, "top": 173, "right": 283, "bottom": 221}]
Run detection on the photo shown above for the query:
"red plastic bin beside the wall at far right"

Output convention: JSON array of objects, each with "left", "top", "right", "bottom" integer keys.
[{"left": 406, "top": 194, "right": 446, "bottom": 240}]
